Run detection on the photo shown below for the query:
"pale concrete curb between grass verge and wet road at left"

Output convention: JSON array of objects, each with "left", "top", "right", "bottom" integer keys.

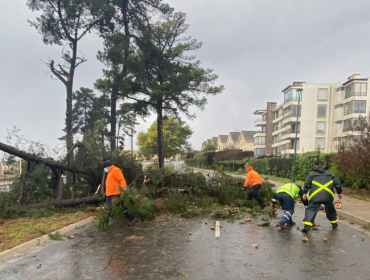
[{"left": 0, "top": 217, "right": 95, "bottom": 262}]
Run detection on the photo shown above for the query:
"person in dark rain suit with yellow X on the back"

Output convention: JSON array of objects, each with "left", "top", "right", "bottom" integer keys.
[{"left": 302, "top": 160, "right": 342, "bottom": 232}]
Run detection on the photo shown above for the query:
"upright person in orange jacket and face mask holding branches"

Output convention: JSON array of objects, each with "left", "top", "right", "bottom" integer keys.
[{"left": 103, "top": 160, "right": 136, "bottom": 226}]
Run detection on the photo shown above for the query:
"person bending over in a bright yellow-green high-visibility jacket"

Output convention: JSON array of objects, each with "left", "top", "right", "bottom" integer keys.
[{"left": 271, "top": 183, "right": 307, "bottom": 228}]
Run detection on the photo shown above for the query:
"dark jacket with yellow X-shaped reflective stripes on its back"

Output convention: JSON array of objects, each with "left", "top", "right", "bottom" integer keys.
[{"left": 304, "top": 166, "right": 342, "bottom": 202}]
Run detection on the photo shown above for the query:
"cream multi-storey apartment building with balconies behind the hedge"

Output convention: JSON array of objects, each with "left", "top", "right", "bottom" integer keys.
[{"left": 253, "top": 74, "right": 370, "bottom": 156}]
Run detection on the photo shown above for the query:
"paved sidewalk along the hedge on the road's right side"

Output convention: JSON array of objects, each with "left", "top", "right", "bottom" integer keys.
[{"left": 194, "top": 168, "right": 370, "bottom": 230}]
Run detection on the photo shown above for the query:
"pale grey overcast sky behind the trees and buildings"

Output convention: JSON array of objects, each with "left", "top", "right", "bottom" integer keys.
[{"left": 0, "top": 0, "right": 370, "bottom": 154}]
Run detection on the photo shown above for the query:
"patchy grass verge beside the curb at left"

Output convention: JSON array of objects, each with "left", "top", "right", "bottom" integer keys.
[{"left": 0, "top": 208, "right": 97, "bottom": 252}]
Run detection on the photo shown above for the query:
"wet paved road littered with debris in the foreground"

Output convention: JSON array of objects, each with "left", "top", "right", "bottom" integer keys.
[{"left": 0, "top": 204, "right": 370, "bottom": 280}]
